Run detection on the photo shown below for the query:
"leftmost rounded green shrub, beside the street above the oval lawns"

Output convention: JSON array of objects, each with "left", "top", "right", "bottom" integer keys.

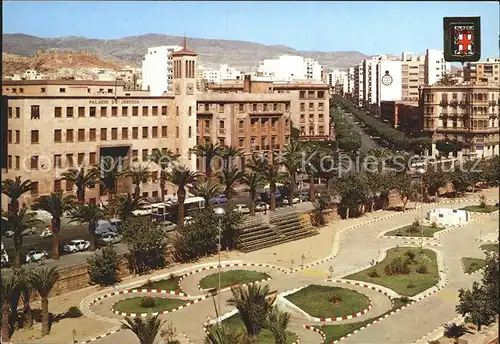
[{"left": 87, "top": 246, "right": 120, "bottom": 286}]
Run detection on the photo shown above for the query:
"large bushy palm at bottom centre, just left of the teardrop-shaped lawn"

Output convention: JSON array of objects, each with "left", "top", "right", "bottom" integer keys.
[{"left": 227, "top": 285, "right": 274, "bottom": 336}]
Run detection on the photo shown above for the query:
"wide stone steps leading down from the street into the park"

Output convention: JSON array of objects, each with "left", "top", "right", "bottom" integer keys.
[{"left": 238, "top": 212, "right": 318, "bottom": 252}]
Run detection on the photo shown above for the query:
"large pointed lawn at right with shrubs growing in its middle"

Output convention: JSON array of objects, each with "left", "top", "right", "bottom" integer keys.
[{"left": 345, "top": 247, "right": 439, "bottom": 296}]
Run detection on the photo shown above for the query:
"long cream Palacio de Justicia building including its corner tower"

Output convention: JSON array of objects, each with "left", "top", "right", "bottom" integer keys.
[{"left": 2, "top": 45, "right": 197, "bottom": 205}]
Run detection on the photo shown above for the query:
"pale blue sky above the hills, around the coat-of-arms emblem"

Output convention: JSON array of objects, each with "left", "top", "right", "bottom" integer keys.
[{"left": 2, "top": 1, "right": 500, "bottom": 57}]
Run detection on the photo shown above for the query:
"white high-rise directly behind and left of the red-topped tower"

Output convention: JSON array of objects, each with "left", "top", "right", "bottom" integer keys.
[{"left": 142, "top": 45, "right": 182, "bottom": 96}]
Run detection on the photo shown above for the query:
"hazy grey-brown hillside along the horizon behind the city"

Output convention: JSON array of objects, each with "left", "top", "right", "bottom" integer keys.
[{"left": 2, "top": 34, "right": 367, "bottom": 71}]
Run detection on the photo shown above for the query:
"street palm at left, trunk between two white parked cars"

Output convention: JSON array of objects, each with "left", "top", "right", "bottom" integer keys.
[{"left": 33, "top": 191, "right": 75, "bottom": 259}]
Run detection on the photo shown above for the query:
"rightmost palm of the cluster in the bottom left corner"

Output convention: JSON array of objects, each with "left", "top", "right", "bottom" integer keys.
[{"left": 29, "top": 266, "right": 59, "bottom": 336}]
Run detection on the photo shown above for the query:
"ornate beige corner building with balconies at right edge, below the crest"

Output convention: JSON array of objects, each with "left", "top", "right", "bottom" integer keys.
[{"left": 420, "top": 84, "right": 500, "bottom": 157}]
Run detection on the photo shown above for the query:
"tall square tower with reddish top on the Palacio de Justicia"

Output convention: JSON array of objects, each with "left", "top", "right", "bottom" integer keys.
[{"left": 172, "top": 37, "right": 198, "bottom": 171}]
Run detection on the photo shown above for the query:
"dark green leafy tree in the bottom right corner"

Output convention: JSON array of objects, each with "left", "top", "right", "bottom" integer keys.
[{"left": 455, "top": 281, "right": 498, "bottom": 331}]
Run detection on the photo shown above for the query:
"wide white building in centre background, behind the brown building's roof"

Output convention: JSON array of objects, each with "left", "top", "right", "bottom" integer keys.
[{"left": 258, "top": 55, "right": 322, "bottom": 82}]
